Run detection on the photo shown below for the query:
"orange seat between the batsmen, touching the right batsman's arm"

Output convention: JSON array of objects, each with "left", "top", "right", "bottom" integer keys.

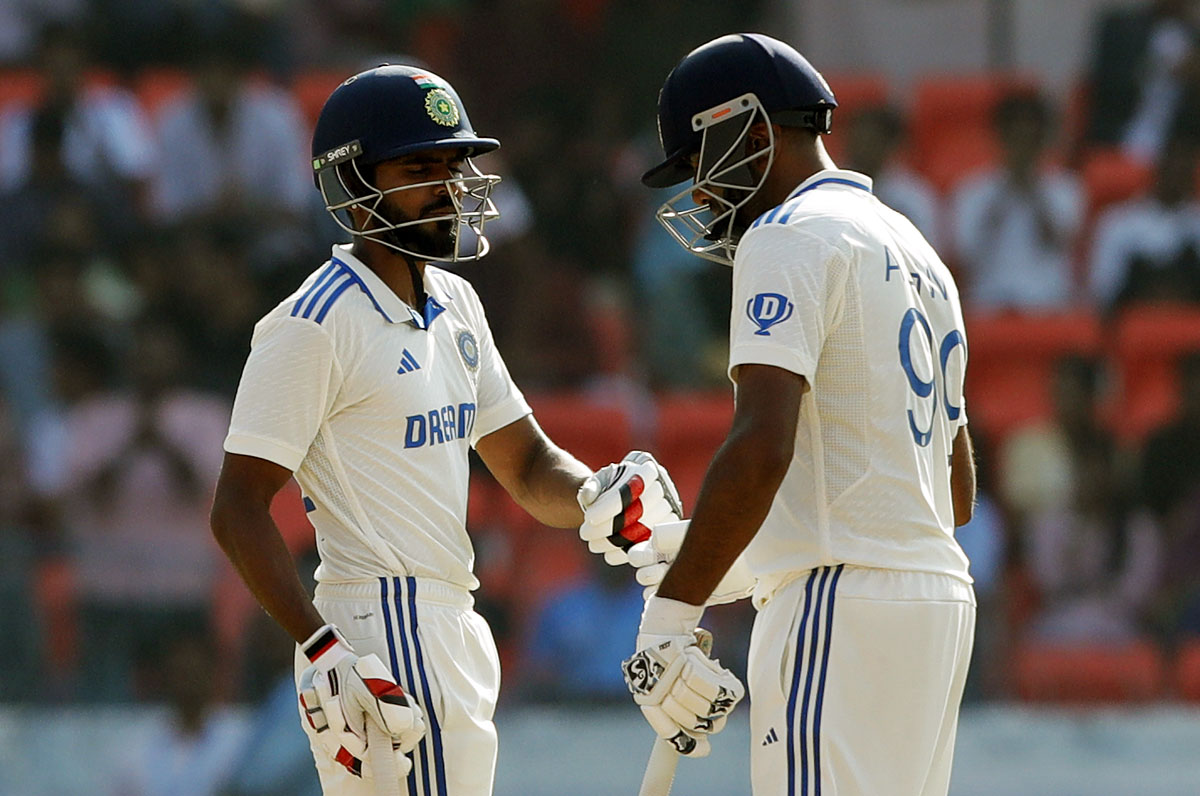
[{"left": 655, "top": 390, "right": 733, "bottom": 514}]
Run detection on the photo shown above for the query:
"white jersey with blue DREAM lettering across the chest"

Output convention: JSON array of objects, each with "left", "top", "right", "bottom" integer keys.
[{"left": 224, "top": 245, "right": 529, "bottom": 588}]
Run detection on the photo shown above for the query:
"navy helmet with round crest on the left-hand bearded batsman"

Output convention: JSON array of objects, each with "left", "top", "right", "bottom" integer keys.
[{"left": 312, "top": 64, "right": 500, "bottom": 262}]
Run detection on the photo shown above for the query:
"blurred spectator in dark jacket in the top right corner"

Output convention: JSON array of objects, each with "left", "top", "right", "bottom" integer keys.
[{"left": 1087, "top": 0, "right": 1200, "bottom": 163}]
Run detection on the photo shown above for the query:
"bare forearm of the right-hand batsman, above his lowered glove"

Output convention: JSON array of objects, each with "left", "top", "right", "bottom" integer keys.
[{"left": 658, "top": 437, "right": 788, "bottom": 605}]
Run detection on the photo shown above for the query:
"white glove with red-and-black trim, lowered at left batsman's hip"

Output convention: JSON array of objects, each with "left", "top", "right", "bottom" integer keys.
[{"left": 299, "top": 624, "right": 425, "bottom": 777}]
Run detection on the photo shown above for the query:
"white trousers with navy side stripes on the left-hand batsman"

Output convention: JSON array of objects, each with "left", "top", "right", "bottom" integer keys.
[{"left": 295, "top": 577, "right": 500, "bottom": 796}]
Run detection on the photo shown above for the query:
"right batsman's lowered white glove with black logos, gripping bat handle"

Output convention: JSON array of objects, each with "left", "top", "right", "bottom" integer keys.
[{"left": 622, "top": 597, "right": 745, "bottom": 758}]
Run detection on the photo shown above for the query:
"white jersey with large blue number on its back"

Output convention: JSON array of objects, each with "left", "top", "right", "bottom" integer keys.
[{"left": 730, "top": 170, "right": 971, "bottom": 590}]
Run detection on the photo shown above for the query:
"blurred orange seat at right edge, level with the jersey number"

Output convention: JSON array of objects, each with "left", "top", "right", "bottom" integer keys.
[{"left": 1114, "top": 304, "right": 1200, "bottom": 441}]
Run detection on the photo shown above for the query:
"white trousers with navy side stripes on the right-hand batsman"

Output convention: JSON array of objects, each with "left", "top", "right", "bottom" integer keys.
[{"left": 749, "top": 564, "right": 976, "bottom": 796}]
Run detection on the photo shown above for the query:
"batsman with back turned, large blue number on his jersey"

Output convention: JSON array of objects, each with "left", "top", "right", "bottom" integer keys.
[{"left": 626, "top": 34, "right": 974, "bottom": 796}]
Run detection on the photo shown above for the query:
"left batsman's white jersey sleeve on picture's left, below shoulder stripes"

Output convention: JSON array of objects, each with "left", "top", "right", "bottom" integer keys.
[{"left": 224, "top": 317, "right": 342, "bottom": 472}]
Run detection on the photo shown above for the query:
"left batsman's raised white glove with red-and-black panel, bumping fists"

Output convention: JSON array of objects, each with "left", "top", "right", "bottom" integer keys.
[{"left": 576, "top": 450, "right": 683, "bottom": 567}]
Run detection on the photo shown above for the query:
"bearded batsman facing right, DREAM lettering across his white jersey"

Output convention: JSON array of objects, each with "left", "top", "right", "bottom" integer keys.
[{"left": 212, "top": 65, "right": 682, "bottom": 796}]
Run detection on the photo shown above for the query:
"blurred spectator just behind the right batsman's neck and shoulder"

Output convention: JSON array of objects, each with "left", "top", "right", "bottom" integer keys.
[{"left": 846, "top": 106, "right": 941, "bottom": 249}]
